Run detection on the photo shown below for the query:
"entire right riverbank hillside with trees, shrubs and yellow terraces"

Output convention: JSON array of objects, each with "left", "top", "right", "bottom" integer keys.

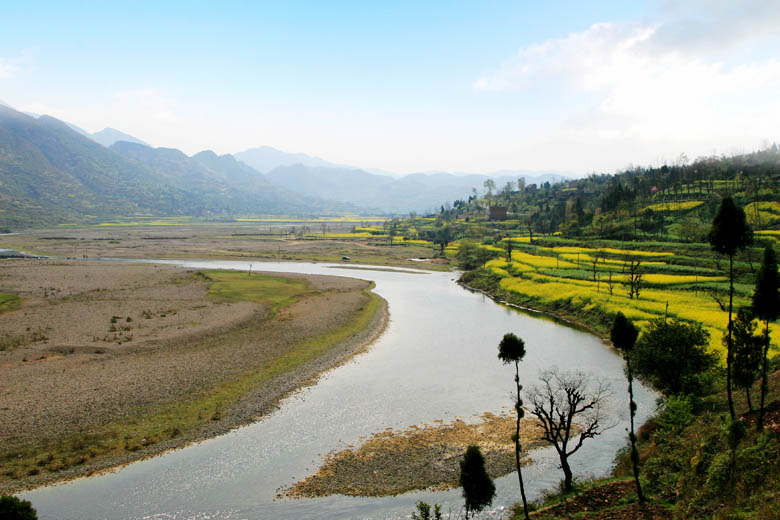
[{"left": 402, "top": 146, "right": 780, "bottom": 519}]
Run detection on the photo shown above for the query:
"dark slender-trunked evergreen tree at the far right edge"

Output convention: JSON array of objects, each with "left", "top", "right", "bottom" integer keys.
[{"left": 753, "top": 247, "right": 780, "bottom": 428}]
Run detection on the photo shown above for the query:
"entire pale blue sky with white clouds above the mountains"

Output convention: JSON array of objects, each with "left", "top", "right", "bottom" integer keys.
[{"left": 0, "top": 0, "right": 780, "bottom": 174}]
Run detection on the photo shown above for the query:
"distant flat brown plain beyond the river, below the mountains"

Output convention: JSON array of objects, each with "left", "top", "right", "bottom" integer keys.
[{"left": 0, "top": 222, "right": 449, "bottom": 269}]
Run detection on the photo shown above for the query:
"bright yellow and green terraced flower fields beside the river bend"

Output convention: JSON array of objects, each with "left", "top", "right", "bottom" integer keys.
[{"left": 460, "top": 241, "right": 780, "bottom": 356}]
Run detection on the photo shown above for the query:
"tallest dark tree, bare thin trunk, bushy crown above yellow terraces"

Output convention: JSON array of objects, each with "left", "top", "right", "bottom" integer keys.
[{"left": 709, "top": 197, "right": 753, "bottom": 421}]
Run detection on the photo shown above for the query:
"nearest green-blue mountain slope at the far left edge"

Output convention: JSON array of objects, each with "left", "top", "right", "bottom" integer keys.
[{"left": 0, "top": 106, "right": 200, "bottom": 228}]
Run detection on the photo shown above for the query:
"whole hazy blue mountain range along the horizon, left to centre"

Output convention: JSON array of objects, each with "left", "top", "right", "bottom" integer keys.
[{"left": 0, "top": 105, "right": 565, "bottom": 229}]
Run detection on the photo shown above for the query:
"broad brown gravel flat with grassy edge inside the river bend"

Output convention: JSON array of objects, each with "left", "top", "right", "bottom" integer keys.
[{"left": 0, "top": 260, "right": 387, "bottom": 491}]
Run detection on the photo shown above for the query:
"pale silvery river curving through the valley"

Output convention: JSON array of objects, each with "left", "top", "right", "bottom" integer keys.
[{"left": 22, "top": 261, "right": 656, "bottom": 520}]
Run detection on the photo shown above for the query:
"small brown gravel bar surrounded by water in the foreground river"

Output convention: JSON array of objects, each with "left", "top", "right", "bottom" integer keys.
[{"left": 284, "top": 413, "right": 540, "bottom": 497}]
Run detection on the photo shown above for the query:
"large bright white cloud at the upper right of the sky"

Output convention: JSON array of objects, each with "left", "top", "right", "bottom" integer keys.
[{"left": 473, "top": 7, "right": 780, "bottom": 171}]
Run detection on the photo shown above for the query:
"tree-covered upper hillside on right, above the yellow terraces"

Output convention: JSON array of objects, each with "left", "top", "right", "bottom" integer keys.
[{"left": 426, "top": 145, "right": 780, "bottom": 241}]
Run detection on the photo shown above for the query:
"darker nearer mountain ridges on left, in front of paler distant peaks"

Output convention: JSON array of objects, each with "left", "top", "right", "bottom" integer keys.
[{"left": 0, "top": 106, "right": 352, "bottom": 229}]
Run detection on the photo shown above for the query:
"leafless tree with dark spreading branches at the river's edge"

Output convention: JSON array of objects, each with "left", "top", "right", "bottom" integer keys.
[{"left": 526, "top": 368, "right": 615, "bottom": 491}]
